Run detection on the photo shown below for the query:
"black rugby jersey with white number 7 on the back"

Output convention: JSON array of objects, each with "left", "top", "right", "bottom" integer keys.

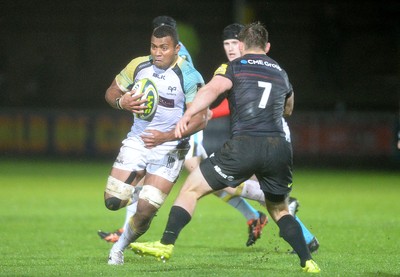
[{"left": 215, "top": 54, "right": 292, "bottom": 136}]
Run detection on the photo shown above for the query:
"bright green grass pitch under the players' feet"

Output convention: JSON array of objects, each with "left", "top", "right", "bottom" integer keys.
[{"left": 0, "top": 159, "right": 400, "bottom": 276}]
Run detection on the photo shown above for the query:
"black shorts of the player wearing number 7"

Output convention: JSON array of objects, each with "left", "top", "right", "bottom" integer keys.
[{"left": 200, "top": 136, "right": 293, "bottom": 195}]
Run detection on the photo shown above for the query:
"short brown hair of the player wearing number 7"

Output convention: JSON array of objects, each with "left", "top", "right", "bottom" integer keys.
[{"left": 238, "top": 22, "right": 268, "bottom": 49}]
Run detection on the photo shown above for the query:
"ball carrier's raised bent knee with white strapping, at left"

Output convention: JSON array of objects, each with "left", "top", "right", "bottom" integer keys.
[{"left": 104, "top": 176, "right": 134, "bottom": 211}]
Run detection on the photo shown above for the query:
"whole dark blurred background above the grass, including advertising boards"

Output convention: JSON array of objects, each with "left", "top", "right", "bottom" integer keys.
[{"left": 0, "top": 0, "right": 400, "bottom": 169}]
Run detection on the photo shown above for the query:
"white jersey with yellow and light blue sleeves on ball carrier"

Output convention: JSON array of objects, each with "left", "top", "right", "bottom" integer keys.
[{"left": 115, "top": 55, "right": 204, "bottom": 148}]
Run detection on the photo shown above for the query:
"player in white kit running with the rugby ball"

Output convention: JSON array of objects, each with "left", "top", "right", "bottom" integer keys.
[{"left": 104, "top": 25, "right": 207, "bottom": 265}]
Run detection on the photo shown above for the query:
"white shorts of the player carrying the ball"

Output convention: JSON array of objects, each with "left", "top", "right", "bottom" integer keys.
[{"left": 113, "top": 137, "right": 189, "bottom": 182}]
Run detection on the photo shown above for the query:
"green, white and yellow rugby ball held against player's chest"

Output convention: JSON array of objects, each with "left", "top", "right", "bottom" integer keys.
[{"left": 132, "top": 78, "right": 159, "bottom": 121}]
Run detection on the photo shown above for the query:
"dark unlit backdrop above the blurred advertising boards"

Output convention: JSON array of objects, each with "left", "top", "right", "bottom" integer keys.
[{"left": 0, "top": 0, "right": 400, "bottom": 111}]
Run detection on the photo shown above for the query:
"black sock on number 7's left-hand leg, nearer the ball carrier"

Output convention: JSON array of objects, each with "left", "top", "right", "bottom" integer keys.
[{"left": 161, "top": 206, "right": 192, "bottom": 244}]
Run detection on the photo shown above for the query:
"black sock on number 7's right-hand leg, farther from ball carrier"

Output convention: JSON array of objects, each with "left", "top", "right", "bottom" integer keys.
[{"left": 276, "top": 215, "right": 311, "bottom": 267}]
